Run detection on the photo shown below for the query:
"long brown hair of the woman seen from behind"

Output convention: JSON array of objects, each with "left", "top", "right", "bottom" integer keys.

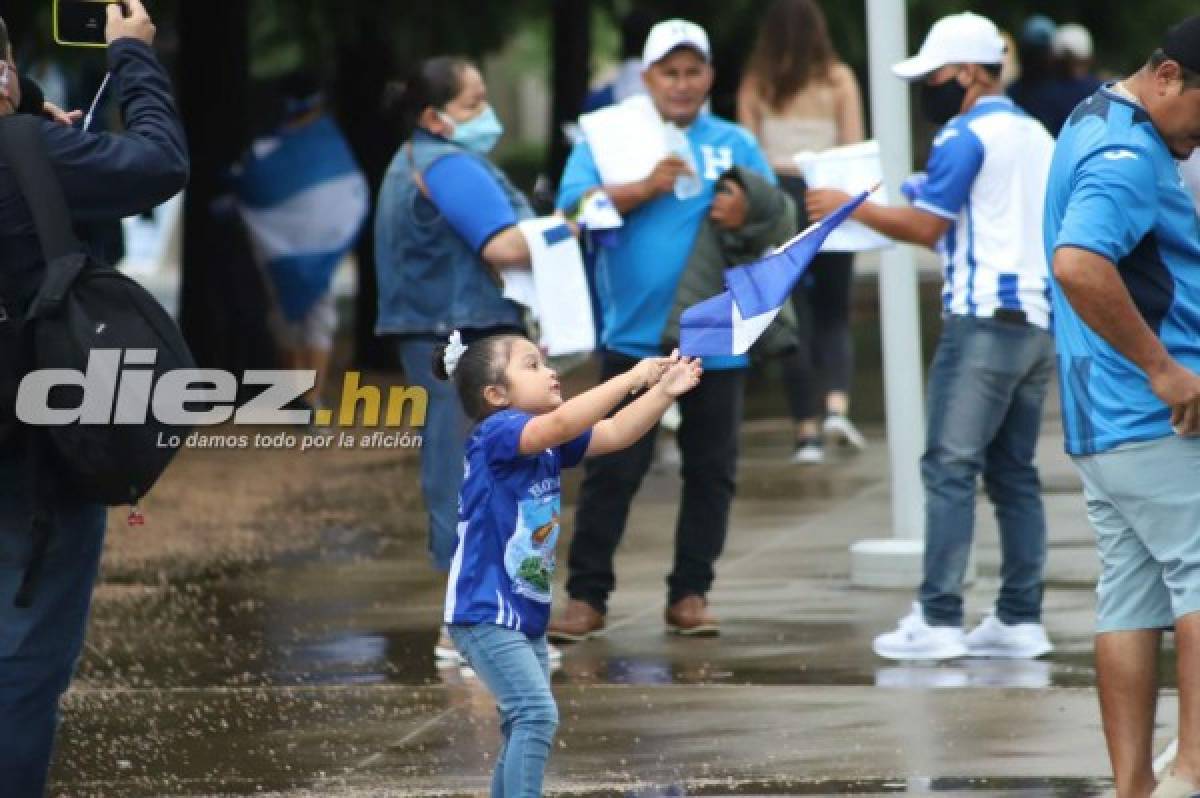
[{"left": 746, "top": 0, "right": 838, "bottom": 110}]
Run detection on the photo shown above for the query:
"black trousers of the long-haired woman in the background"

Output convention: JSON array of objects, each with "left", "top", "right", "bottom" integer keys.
[{"left": 779, "top": 175, "right": 854, "bottom": 421}]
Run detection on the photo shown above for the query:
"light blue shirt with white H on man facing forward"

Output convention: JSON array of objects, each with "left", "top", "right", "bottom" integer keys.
[{"left": 558, "top": 114, "right": 775, "bottom": 370}]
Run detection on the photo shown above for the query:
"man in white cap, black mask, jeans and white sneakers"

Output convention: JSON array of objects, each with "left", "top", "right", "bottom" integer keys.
[{"left": 808, "top": 13, "right": 1054, "bottom": 660}]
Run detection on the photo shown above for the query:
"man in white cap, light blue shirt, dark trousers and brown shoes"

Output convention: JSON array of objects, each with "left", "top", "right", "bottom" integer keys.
[{"left": 548, "top": 19, "right": 774, "bottom": 642}]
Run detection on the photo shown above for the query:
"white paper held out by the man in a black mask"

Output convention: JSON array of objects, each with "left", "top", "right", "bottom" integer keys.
[{"left": 793, "top": 140, "right": 893, "bottom": 252}]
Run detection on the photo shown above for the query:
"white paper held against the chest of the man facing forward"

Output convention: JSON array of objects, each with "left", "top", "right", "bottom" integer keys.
[{"left": 580, "top": 95, "right": 670, "bottom": 185}]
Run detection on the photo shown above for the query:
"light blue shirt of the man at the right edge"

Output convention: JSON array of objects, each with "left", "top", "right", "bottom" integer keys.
[{"left": 1045, "top": 88, "right": 1200, "bottom": 455}]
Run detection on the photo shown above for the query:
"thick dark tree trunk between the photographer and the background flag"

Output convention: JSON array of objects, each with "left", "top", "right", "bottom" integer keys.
[{"left": 179, "top": 2, "right": 276, "bottom": 374}]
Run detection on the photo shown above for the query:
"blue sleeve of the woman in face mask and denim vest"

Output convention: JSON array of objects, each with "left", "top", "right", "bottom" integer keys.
[{"left": 421, "top": 155, "right": 517, "bottom": 253}]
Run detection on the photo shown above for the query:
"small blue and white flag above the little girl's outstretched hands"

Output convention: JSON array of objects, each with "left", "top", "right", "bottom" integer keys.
[{"left": 679, "top": 191, "right": 870, "bottom": 358}]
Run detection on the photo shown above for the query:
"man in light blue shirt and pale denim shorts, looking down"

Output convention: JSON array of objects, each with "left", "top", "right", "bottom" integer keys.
[{"left": 1045, "top": 16, "right": 1200, "bottom": 798}]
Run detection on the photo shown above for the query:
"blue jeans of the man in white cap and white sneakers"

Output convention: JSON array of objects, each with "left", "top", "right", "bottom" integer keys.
[{"left": 920, "top": 316, "right": 1054, "bottom": 626}]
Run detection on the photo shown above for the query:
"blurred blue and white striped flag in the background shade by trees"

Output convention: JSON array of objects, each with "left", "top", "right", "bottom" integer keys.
[{"left": 234, "top": 116, "right": 371, "bottom": 322}]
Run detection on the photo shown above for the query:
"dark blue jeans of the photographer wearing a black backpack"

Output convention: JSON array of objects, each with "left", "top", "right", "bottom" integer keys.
[{"left": 0, "top": 448, "right": 106, "bottom": 798}]
